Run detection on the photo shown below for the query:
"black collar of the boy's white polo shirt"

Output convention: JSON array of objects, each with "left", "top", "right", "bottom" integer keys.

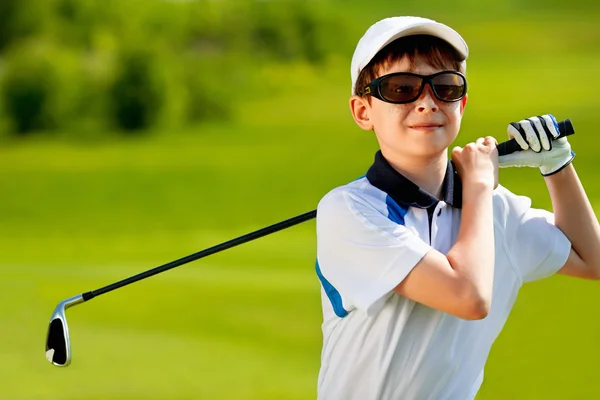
[{"left": 366, "top": 150, "right": 462, "bottom": 208}]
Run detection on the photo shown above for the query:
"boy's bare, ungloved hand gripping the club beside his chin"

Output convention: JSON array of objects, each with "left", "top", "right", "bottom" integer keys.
[{"left": 452, "top": 136, "right": 498, "bottom": 189}]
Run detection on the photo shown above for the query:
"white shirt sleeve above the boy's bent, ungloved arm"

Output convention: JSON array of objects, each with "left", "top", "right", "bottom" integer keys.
[{"left": 317, "top": 189, "right": 431, "bottom": 315}]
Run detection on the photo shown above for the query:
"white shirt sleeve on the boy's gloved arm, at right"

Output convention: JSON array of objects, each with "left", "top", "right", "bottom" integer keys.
[{"left": 506, "top": 187, "right": 571, "bottom": 282}]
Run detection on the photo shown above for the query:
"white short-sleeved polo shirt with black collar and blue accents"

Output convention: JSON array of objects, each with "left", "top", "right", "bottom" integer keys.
[{"left": 316, "top": 152, "right": 571, "bottom": 400}]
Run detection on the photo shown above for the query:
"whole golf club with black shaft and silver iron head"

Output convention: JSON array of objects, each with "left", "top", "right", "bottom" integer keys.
[{"left": 46, "top": 119, "right": 575, "bottom": 367}]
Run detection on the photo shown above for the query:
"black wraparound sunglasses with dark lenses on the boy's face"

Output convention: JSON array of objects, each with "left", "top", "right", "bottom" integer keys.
[{"left": 362, "top": 71, "right": 467, "bottom": 104}]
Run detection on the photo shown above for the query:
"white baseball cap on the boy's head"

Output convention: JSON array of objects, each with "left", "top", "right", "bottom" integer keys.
[{"left": 350, "top": 17, "right": 469, "bottom": 94}]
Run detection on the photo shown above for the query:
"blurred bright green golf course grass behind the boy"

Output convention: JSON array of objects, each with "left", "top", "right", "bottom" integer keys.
[{"left": 0, "top": 4, "right": 600, "bottom": 400}]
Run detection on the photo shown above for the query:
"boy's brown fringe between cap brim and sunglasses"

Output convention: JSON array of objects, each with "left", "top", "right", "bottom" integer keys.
[{"left": 354, "top": 35, "right": 465, "bottom": 96}]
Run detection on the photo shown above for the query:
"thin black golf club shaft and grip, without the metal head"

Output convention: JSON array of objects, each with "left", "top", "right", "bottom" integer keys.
[{"left": 82, "top": 119, "right": 575, "bottom": 301}]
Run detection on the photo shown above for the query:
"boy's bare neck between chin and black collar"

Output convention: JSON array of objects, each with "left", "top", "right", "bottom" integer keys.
[{"left": 381, "top": 149, "right": 448, "bottom": 199}]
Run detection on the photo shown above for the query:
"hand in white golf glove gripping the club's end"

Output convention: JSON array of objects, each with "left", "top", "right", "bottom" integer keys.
[{"left": 498, "top": 114, "right": 575, "bottom": 176}]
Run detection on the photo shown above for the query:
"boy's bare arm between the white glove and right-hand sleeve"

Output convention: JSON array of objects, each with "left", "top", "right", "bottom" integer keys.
[{"left": 545, "top": 165, "right": 600, "bottom": 279}]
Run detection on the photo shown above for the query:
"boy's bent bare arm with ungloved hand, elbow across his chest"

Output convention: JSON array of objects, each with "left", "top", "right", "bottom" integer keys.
[{"left": 394, "top": 138, "right": 497, "bottom": 319}]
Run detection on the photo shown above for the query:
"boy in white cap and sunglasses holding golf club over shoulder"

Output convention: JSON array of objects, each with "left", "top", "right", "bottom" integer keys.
[{"left": 317, "top": 17, "right": 600, "bottom": 400}]
